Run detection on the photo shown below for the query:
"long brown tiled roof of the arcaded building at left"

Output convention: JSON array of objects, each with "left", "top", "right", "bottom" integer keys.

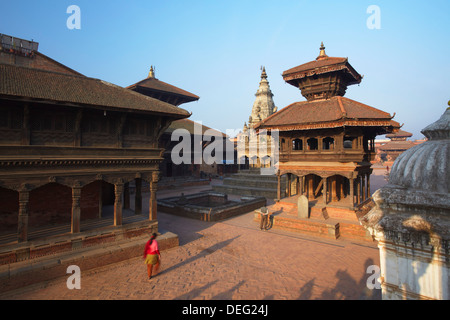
[{"left": 0, "top": 64, "right": 190, "bottom": 118}]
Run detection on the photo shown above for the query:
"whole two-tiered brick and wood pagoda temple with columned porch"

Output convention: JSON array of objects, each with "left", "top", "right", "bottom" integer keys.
[{"left": 255, "top": 43, "right": 400, "bottom": 238}]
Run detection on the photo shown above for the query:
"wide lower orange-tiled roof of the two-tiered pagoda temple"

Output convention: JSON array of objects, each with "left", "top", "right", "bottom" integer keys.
[{"left": 256, "top": 96, "right": 400, "bottom": 130}]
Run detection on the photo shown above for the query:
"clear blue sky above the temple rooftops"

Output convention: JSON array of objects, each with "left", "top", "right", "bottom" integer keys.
[{"left": 0, "top": 0, "right": 450, "bottom": 139}]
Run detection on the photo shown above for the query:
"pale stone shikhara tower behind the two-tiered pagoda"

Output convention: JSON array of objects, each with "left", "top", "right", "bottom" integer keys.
[{"left": 238, "top": 67, "right": 277, "bottom": 167}]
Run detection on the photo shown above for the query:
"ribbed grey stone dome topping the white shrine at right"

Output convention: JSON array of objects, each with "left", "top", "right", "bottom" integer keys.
[{"left": 389, "top": 107, "right": 450, "bottom": 194}]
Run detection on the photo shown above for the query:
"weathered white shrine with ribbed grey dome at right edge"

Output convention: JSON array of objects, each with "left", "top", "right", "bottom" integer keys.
[{"left": 361, "top": 108, "right": 450, "bottom": 300}]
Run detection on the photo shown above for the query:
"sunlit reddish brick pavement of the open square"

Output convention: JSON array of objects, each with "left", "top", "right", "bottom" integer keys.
[{"left": 0, "top": 192, "right": 381, "bottom": 300}]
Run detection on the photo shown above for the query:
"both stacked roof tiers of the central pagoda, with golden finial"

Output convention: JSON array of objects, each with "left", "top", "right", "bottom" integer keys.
[{"left": 256, "top": 43, "right": 400, "bottom": 135}]
